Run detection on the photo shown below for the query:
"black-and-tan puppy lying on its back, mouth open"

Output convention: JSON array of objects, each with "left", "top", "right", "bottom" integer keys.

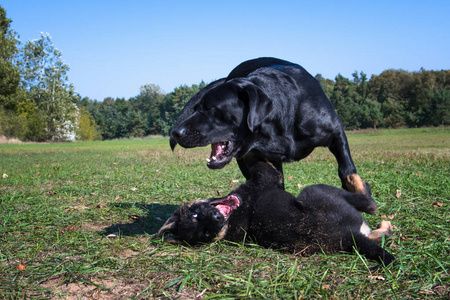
[{"left": 157, "top": 162, "right": 394, "bottom": 265}]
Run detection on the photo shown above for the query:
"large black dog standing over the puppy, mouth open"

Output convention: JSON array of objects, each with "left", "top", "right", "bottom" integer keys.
[{"left": 170, "top": 58, "right": 377, "bottom": 213}]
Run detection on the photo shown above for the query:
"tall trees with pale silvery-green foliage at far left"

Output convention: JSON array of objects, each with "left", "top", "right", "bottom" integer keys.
[{"left": 0, "top": 7, "right": 78, "bottom": 141}]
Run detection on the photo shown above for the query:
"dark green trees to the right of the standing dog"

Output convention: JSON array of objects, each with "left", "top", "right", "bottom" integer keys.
[{"left": 316, "top": 68, "right": 450, "bottom": 130}]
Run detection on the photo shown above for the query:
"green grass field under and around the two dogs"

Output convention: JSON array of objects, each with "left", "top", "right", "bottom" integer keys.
[{"left": 0, "top": 128, "right": 450, "bottom": 299}]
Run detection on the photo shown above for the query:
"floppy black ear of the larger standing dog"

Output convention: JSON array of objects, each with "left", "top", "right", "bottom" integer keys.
[{"left": 245, "top": 85, "right": 273, "bottom": 132}]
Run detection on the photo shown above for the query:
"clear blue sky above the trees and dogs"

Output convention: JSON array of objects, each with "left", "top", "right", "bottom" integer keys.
[{"left": 0, "top": 0, "right": 450, "bottom": 101}]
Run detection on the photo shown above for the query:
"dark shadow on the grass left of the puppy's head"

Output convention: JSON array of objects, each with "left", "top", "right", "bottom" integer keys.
[{"left": 102, "top": 203, "right": 178, "bottom": 236}]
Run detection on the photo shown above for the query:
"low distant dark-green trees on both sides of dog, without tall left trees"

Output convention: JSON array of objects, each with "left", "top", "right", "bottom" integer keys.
[{"left": 84, "top": 69, "right": 450, "bottom": 139}]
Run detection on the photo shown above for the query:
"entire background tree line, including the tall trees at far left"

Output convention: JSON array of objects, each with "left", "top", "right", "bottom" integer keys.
[{"left": 0, "top": 6, "right": 450, "bottom": 141}]
